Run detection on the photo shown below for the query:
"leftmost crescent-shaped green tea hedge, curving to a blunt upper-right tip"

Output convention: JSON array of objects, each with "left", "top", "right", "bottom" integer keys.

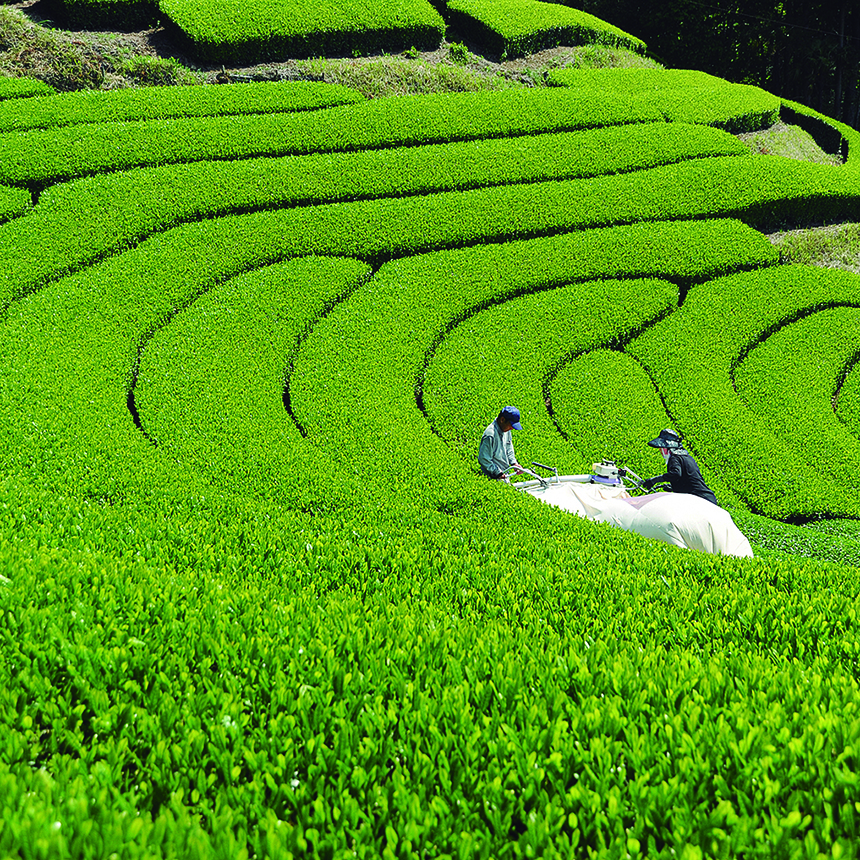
[{"left": 134, "top": 258, "right": 370, "bottom": 505}]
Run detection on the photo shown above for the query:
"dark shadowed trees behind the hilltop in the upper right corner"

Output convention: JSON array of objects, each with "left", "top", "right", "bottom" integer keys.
[{"left": 565, "top": 0, "right": 860, "bottom": 128}]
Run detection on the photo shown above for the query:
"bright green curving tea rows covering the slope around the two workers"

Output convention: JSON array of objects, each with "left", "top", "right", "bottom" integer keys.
[{"left": 0, "top": 70, "right": 860, "bottom": 858}]
